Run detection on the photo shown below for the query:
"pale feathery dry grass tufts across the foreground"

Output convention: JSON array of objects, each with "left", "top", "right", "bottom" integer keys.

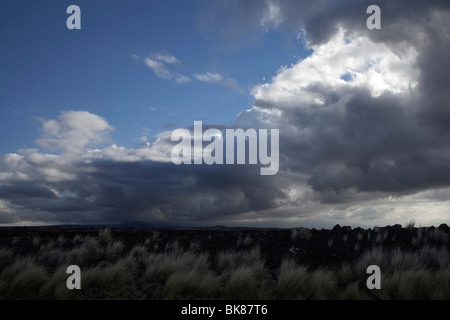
[{"left": 0, "top": 228, "right": 450, "bottom": 300}]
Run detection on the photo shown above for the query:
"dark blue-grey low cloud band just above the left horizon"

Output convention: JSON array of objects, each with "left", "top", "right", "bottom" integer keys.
[{"left": 0, "top": 160, "right": 283, "bottom": 225}]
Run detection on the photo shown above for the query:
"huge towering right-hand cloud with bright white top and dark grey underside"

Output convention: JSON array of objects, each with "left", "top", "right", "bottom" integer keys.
[{"left": 239, "top": 2, "right": 450, "bottom": 201}]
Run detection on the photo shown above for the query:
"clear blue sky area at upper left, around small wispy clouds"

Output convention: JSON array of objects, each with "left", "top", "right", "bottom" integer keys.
[{"left": 0, "top": 0, "right": 306, "bottom": 153}]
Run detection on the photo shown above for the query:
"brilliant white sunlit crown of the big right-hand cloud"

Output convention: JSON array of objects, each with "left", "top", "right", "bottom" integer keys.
[{"left": 252, "top": 29, "right": 419, "bottom": 108}]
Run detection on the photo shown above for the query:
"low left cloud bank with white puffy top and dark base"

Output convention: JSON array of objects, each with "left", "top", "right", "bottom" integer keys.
[{"left": 0, "top": 112, "right": 285, "bottom": 225}]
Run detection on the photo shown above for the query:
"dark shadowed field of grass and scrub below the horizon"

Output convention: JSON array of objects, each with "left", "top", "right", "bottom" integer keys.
[{"left": 0, "top": 223, "right": 450, "bottom": 299}]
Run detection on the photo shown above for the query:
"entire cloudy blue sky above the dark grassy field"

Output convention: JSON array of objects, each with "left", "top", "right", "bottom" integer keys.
[{"left": 0, "top": 0, "right": 450, "bottom": 228}]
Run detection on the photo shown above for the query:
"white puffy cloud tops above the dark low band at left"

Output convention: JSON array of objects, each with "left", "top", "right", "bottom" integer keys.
[{"left": 0, "top": 111, "right": 172, "bottom": 185}]
